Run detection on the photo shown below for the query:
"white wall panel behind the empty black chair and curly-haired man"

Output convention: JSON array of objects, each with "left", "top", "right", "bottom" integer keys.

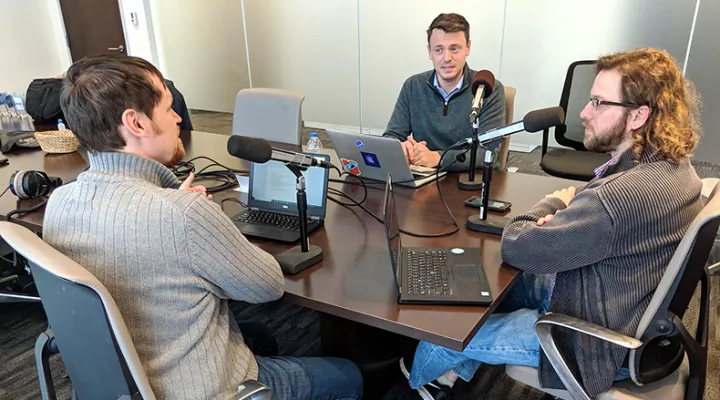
[{"left": 500, "top": 0, "right": 695, "bottom": 145}]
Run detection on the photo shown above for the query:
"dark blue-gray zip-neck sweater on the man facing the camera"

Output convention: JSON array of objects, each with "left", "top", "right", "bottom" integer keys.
[{"left": 383, "top": 64, "right": 505, "bottom": 171}]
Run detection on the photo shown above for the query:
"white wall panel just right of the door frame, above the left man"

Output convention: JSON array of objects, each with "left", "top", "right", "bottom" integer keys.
[{"left": 149, "top": 0, "right": 249, "bottom": 112}]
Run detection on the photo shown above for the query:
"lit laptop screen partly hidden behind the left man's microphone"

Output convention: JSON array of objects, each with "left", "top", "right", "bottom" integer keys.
[{"left": 248, "top": 154, "right": 330, "bottom": 219}]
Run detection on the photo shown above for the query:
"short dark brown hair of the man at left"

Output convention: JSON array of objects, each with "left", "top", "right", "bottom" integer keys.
[{"left": 60, "top": 55, "right": 165, "bottom": 152}]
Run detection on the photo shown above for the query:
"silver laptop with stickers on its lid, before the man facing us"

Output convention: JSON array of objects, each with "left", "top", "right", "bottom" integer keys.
[{"left": 327, "top": 129, "right": 446, "bottom": 188}]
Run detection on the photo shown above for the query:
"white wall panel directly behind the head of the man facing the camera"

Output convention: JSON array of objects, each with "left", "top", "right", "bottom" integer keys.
[{"left": 360, "top": 0, "right": 505, "bottom": 131}]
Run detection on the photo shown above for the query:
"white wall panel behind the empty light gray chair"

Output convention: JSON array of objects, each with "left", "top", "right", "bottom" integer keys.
[{"left": 244, "top": 0, "right": 360, "bottom": 126}]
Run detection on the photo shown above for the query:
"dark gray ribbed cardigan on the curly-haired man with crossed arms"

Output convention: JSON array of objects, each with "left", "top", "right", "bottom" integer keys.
[{"left": 502, "top": 150, "right": 703, "bottom": 397}]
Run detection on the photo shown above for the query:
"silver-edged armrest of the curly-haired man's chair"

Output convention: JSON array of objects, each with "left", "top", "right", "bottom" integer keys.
[{"left": 535, "top": 313, "right": 642, "bottom": 400}]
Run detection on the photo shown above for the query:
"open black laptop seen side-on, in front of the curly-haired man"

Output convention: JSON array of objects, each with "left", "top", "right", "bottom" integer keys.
[{"left": 383, "top": 175, "right": 493, "bottom": 306}]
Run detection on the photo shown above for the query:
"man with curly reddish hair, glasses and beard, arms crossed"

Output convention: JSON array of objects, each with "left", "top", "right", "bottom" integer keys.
[{"left": 400, "top": 48, "right": 703, "bottom": 399}]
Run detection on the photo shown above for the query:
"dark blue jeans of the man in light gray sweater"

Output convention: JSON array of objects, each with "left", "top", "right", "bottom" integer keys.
[{"left": 255, "top": 357, "right": 363, "bottom": 400}]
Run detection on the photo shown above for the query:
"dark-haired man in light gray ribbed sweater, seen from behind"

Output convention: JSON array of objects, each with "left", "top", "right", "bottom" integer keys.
[{"left": 43, "top": 56, "right": 362, "bottom": 400}]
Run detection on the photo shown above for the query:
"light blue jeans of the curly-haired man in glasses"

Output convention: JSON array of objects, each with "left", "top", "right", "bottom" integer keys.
[{"left": 410, "top": 274, "right": 630, "bottom": 389}]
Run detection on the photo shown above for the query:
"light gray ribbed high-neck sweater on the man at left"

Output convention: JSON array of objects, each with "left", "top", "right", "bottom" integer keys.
[{"left": 43, "top": 153, "right": 285, "bottom": 399}]
